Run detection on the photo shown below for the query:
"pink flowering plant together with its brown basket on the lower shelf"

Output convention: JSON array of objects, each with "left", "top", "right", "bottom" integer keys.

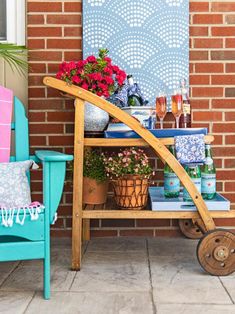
[{"left": 104, "top": 147, "right": 153, "bottom": 210}]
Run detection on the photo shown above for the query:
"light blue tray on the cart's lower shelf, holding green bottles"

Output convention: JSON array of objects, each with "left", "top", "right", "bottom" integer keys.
[{"left": 149, "top": 187, "right": 230, "bottom": 211}]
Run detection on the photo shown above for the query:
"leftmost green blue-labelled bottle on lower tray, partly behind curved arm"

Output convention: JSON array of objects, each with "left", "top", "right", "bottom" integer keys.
[{"left": 164, "top": 145, "right": 180, "bottom": 198}]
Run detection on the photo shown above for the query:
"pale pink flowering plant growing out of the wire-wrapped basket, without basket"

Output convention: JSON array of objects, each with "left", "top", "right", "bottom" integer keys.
[{"left": 104, "top": 147, "right": 153, "bottom": 180}]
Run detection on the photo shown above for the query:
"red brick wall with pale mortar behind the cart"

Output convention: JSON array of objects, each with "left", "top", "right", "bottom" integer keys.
[{"left": 27, "top": 0, "right": 235, "bottom": 236}]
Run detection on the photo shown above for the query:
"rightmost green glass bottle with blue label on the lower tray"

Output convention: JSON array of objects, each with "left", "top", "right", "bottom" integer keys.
[{"left": 202, "top": 144, "right": 216, "bottom": 200}]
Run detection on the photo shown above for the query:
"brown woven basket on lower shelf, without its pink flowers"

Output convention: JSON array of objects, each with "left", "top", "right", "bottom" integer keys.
[{"left": 111, "top": 175, "right": 149, "bottom": 210}]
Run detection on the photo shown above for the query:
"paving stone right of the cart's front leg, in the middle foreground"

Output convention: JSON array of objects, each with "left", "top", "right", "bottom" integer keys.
[{"left": 71, "top": 252, "right": 150, "bottom": 292}]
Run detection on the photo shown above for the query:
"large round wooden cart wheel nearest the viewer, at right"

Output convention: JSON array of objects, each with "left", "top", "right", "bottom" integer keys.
[{"left": 197, "top": 229, "right": 235, "bottom": 276}]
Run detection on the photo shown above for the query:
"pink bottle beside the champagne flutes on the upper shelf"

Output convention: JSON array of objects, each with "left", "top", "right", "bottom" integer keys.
[{"left": 179, "top": 79, "right": 191, "bottom": 128}]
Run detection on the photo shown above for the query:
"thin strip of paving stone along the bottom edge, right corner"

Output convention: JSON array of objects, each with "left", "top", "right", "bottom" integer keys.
[{"left": 157, "top": 304, "right": 235, "bottom": 314}]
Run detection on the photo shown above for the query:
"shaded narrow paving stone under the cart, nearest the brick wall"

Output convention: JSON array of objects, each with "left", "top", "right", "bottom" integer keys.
[{"left": 87, "top": 237, "right": 146, "bottom": 252}]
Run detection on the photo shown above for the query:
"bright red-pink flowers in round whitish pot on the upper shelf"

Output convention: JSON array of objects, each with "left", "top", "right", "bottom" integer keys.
[{"left": 56, "top": 49, "right": 126, "bottom": 132}]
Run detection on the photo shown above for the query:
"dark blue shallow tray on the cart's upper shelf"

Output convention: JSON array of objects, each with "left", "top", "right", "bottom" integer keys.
[{"left": 104, "top": 128, "right": 207, "bottom": 138}]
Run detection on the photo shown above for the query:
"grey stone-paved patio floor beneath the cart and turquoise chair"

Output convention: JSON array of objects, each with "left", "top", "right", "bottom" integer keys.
[{"left": 0, "top": 238, "right": 235, "bottom": 314}]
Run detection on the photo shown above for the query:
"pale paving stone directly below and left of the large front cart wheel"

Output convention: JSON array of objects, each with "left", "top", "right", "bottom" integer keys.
[{"left": 150, "top": 256, "right": 232, "bottom": 304}]
